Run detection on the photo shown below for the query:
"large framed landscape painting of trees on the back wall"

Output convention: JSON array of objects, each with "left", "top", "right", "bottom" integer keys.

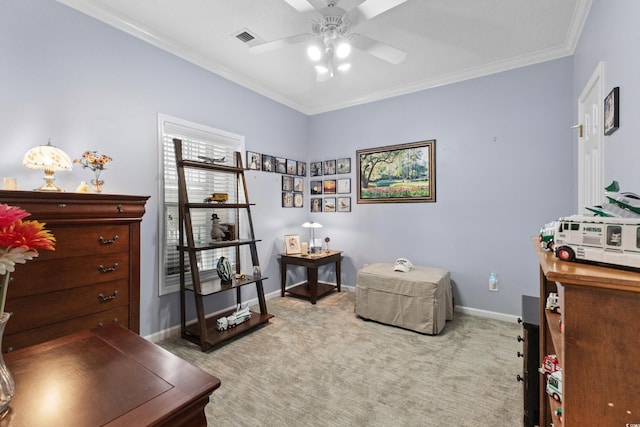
[{"left": 356, "top": 139, "right": 436, "bottom": 203}]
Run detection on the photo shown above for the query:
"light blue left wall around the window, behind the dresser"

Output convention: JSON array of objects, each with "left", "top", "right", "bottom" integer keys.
[{"left": 0, "top": 0, "right": 308, "bottom": 335}]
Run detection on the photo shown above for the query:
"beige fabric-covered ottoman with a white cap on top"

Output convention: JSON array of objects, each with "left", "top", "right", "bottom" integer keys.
[{"left": 355, "top": 263, "right": 453, "bottom": 335}]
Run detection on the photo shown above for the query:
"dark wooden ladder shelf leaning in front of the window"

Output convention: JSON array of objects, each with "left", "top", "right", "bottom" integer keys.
[{"left": 173, "top": 139, "right": 273, "bottom": 351}]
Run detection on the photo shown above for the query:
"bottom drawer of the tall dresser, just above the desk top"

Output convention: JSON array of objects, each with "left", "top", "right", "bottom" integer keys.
[{"left": 2, "top": 306, "right": 129, "bottom": 353}]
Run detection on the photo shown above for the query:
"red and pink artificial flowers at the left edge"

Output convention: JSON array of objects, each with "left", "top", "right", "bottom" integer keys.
[{"left": 0, "top": 204, "right": 56, "bottom": 315}]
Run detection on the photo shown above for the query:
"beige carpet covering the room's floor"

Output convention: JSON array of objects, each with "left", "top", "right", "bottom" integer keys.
[{"left": 159, "top": 292, "right": 523, "bottom": 427}]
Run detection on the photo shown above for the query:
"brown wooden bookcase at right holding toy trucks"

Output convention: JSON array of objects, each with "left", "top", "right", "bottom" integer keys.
[{"left": 532, "top": 238, "right": 640, "bottom": 427}]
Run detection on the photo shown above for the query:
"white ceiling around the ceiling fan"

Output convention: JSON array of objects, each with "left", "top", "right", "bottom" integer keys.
[{"left": 58, "top": 0, "right": 591, "bottom": 115}]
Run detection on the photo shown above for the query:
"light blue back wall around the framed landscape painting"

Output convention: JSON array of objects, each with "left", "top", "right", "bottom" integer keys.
[{"left": 310, "top": 58, "right": 572, "bottom": 314}]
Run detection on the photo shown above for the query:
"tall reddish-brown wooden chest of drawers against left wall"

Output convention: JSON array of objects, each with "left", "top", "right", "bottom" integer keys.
[{"left": 0, "top": 191, "right": 148, "bottom": 353}]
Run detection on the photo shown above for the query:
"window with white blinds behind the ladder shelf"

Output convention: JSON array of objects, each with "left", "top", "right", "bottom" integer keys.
[{"left": 158, "top": 114, "right": 244, "bottom": 295}]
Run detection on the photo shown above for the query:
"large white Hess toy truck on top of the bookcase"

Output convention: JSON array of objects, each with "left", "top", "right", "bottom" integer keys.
[{"left": 554, "top": 215, "right": 640, "bottom": 268}]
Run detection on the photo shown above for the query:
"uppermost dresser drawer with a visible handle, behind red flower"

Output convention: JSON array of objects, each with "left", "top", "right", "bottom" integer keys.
[{"left": 37, "top": 224, "right": 129, "bottom": 260}]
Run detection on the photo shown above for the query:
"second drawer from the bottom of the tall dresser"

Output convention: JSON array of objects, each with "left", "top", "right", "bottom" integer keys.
[{"left": 5, "top": 280, "right": 129, "bottom": 334}]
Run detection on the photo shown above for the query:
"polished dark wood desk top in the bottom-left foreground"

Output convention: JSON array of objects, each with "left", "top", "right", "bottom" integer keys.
[{"left": 0, "top": 325, "right": 220, "bottom": 427}]
